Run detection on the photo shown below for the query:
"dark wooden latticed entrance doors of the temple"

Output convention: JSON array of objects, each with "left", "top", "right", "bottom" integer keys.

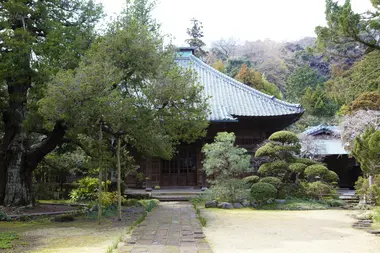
[{"left": 161, "top": 146, "right": 197, "bottom": 186}]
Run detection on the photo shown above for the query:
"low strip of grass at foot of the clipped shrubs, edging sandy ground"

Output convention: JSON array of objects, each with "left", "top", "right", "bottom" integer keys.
[{"left": 257, "top": 199, "right": 330, "bottom": 210}]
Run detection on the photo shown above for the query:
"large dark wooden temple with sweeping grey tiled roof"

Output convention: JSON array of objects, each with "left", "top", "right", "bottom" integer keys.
[{"left": 127, "top": 48, "right": 304, "bottom": 190}]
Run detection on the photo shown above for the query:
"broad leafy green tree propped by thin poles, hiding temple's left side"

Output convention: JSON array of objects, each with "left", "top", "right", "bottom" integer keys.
[{"left": 39, "top": 0, "right": 208, "bottom": 214}]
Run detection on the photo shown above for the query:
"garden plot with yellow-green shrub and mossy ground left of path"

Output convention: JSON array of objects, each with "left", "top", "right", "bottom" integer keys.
[{"left": 0, "top": 177, "right": 158, "bottom": 252}]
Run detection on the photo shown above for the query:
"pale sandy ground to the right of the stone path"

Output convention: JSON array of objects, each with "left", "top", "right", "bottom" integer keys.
[{"left": 202, "top": 209, "right": 380, "bottom": 253}]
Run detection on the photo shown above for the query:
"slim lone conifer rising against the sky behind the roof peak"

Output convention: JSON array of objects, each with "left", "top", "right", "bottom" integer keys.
[{"left": 185, "top": 18, "right": 207, "bottom": 59}]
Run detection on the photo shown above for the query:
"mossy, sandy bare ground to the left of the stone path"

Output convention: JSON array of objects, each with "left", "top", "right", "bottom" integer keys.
[{"left": 0, "top": 207, "right": 144, "bottom": 253}]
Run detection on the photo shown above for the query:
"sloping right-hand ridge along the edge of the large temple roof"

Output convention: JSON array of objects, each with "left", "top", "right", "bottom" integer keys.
[{"left": 184, "top": 55, "right": 302, "bottom": 108}]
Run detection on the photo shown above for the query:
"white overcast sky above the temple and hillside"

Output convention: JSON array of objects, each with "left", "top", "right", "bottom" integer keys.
[{"left": 97, "top": 0, "right": 371, "bottom": 46}]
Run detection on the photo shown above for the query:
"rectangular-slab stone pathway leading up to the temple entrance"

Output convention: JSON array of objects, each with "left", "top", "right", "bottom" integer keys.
[{"left": 118, "top": 202, "right": 212, "bottom": 253}]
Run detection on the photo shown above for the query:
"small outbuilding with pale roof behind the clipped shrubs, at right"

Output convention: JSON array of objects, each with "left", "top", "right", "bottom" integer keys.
[{"left": 300, "top": 125, "right": 362, "bottom": 189}]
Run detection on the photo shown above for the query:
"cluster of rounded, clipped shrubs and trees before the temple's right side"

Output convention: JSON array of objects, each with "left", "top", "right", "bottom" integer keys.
[{"left": 193, "top": 131, "right": 345, "bottom": 210}]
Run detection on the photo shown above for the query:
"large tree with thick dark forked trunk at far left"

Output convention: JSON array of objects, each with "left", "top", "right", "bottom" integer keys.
[{"left": 0, "top": 0, "right": 101, "bottom": 205}]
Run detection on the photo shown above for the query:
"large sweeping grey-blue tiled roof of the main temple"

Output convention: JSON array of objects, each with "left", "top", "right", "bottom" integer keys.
[{"left": 176, "top": 54, "right": 303, "bottom": 121}]
